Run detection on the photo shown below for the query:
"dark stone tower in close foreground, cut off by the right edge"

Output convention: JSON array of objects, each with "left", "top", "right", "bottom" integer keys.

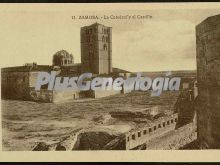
[{"left": 196, "top": 15, "right": 220, "bottom": 149}]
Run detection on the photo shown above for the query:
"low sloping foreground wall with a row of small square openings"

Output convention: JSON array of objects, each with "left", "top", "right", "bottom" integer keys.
[{"left": 125, "top": 114, "right": 178, "bottom": 150}]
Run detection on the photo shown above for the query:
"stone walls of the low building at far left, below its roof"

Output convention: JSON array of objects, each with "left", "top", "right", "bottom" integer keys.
[{"left": 1, "top": 68, "right": 79, "bottom": 103}]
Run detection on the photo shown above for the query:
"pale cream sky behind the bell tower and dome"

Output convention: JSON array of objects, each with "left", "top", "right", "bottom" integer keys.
[{"left": 0, "top": 4, "right": 220, "bottom": 72}]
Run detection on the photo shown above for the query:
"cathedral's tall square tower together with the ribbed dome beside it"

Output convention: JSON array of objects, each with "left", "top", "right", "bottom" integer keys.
[{"left": 49, "top": 23, "right": 113, "bottom": 74}]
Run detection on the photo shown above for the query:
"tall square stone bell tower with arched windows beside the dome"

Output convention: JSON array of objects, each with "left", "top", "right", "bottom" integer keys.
[{"left": 81, "top": 23, "right": 112, "bottom": 74}]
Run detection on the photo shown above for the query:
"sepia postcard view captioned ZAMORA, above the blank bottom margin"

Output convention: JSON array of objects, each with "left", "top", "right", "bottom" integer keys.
[{"left": 0, "top": 3, "right": 220, "bottom": 152}]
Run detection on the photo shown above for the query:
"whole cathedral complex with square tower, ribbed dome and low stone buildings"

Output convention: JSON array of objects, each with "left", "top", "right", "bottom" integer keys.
[{"left": 1, "top": 23, "right": 130, "bottom": 102}]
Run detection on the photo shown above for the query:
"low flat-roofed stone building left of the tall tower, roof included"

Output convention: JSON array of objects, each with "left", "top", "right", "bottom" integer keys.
[{"left": 1, "top": 63, "right": 80, "bottom": 103}]
